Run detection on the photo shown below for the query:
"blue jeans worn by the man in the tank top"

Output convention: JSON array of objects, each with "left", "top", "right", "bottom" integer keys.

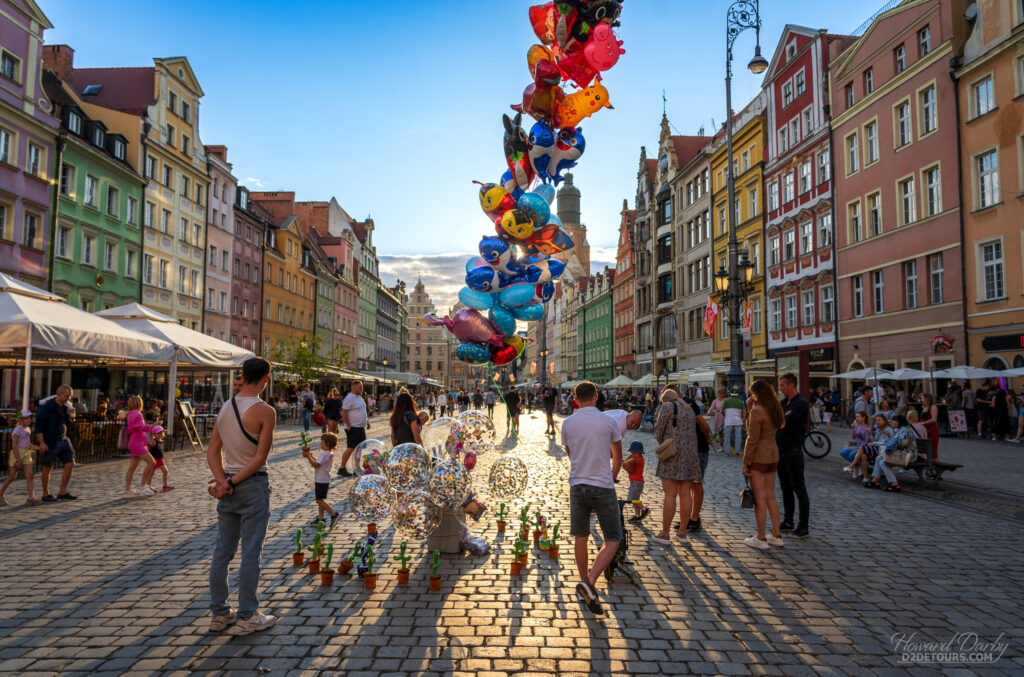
[{"left": 210, "top": 475, "right": 270, "bottom": 619}]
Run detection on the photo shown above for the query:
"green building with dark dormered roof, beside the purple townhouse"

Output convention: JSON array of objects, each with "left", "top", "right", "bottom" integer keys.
[{"left": 43, "top": 71, "right": 145, "bottom": 312}]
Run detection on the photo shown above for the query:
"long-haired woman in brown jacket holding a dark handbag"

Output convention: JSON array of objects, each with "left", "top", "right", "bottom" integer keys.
[{"left": 743, "top": 380, "right": 785, "bottom": 550}]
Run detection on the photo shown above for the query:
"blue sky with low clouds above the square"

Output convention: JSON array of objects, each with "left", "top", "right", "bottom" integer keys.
[{"left": 39, "top": 0, "right": 883, "bottom": 308}]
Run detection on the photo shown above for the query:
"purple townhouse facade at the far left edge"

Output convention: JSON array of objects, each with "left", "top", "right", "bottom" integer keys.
[{"left": 0, "top": 0, "right": 59, "bottom": 288}]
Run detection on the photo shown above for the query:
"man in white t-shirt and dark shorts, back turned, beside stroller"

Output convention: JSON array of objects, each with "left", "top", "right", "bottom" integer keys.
[{"left": 562, "top": 381, "right": 623, "bottom": 613}]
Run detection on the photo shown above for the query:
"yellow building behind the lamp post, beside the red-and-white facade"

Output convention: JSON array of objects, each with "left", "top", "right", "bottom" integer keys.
[{"left": 711, "top": 93, "right": 768, "bottom": 373}]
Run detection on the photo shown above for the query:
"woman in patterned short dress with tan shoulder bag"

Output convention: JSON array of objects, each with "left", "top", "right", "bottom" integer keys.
[{"left": 653, "top": 388, "right": 700, "bottom": 545}]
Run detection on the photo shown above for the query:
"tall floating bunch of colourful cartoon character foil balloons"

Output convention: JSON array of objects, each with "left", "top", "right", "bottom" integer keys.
[{"left": 438, "top": 0, "right": 625, "bottom": 366}]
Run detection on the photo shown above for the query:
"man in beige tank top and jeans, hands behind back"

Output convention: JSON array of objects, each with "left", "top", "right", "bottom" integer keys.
[{"left": 206, "top": 357, "right": 278, "bottom": 635}]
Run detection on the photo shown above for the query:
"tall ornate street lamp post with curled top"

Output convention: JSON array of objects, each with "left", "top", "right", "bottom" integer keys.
[{"left": 716, "top": 0, "right": 768, "bottom": 390}]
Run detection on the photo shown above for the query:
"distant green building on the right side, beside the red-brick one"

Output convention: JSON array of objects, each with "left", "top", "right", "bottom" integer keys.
[{"left": 579, "top": 268, "right": 614, "bottom": 385}]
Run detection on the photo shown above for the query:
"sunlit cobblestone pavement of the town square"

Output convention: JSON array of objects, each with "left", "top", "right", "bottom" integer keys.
[{"left": 0, "top": 403, "right": 1024, "bottom": 676}]
